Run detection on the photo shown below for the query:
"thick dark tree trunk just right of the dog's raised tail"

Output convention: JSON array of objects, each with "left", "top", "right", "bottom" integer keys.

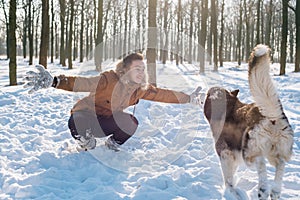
[{"left": 279, "top": 0, "right": 288, "bottom": 75}]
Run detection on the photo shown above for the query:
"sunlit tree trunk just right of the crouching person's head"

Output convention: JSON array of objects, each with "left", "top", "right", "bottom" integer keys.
[{"left": 146, "top": 0, "right": 157, "bottom": 85}]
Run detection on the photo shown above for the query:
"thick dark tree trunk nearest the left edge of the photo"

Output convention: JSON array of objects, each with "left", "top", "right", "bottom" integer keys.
[{"left": 9, "top": 0, "right": 17, "bottom": 85}]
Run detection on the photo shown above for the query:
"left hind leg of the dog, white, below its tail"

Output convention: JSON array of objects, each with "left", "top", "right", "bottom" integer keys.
[{"left": 256, "top": 157, "right": 269, "bottom": 200}]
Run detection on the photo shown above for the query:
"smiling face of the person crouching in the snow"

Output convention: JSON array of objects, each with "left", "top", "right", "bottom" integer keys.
[{"left": 128, "top": 60, "right": 145, "bottom": 84}]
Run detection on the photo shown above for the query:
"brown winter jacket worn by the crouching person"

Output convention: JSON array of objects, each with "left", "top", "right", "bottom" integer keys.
[{"left": 57, "top": 70, "right": 190, "bottom": 116}]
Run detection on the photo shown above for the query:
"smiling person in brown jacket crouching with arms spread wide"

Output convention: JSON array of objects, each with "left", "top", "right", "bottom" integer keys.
[{"left": 26, "top": 53, "right": 204, "bottom": 151}]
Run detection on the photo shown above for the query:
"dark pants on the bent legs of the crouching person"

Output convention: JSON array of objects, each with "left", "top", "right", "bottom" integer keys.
[{"left": 68, "top": 112, "right": 138, "bottom": 144}]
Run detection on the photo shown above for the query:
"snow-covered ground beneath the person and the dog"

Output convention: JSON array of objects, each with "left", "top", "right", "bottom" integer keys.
[{"left": 0, "top": 59, "right": 300, "bottom": 200}]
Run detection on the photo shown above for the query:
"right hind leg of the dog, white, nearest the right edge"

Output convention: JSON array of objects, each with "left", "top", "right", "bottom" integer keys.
[{"left": 271, "top": 159, "right": 285, "bottom": 200}]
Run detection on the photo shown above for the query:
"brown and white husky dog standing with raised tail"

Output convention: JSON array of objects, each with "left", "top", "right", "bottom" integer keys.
[{"left": 204, "top": 45, "right": 294, "bottom": 199}]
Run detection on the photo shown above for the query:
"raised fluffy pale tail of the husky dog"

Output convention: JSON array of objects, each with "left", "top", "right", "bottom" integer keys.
[{"left": 248, "top": 44, "right": 283, "bottom": 120}]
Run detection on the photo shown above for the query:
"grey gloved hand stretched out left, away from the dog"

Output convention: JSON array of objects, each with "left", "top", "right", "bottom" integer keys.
[{"left": 24, "top": 65, "right": 53, "bottom": 94}]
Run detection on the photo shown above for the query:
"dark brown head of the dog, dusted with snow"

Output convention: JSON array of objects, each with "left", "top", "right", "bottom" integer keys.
[{"left": 204, "top": 87, "right": 239, "bottom": 122}]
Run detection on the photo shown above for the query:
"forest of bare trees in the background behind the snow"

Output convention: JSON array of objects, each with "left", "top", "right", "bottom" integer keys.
[{"left": 0, "top": 0, "right": 300, "bottom": 85}]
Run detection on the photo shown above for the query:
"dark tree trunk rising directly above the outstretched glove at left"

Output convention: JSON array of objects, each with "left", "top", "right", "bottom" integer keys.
[{"left": 39, "top": 0, "right": 49, "bottom": 69}]
